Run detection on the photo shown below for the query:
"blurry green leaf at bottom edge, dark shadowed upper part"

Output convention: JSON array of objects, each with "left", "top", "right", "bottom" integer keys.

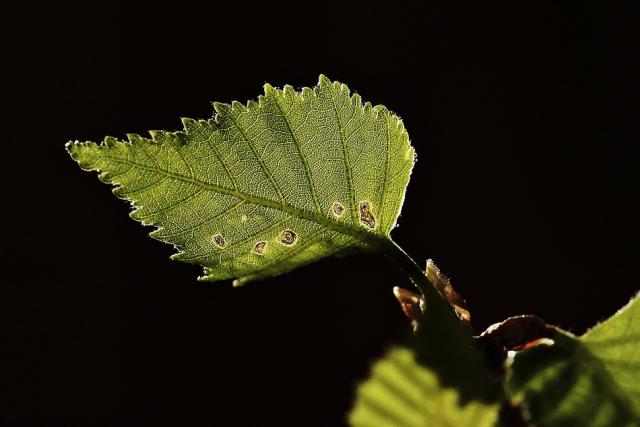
[{"left": 349, "top": 301, "right": 502, "bottom": 427}]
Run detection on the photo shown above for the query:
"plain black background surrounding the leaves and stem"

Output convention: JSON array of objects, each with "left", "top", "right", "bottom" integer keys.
[{"left": 0, "top": 1, "right": 640, "bottom": 426}]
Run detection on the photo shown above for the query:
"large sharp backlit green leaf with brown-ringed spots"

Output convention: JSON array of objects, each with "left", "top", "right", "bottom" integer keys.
[{"left": 67, "top": 76, "right": 414, "bottom": 284}]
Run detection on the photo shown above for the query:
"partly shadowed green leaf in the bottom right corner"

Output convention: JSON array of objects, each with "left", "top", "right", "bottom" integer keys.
[{"left": 507, "top": 296, "right": 640, "bottom": 427}]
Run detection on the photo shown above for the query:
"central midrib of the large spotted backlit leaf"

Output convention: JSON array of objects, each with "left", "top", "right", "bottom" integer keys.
[{"left": 105, "top": 155, "right": 389, "bottom": 248}]
